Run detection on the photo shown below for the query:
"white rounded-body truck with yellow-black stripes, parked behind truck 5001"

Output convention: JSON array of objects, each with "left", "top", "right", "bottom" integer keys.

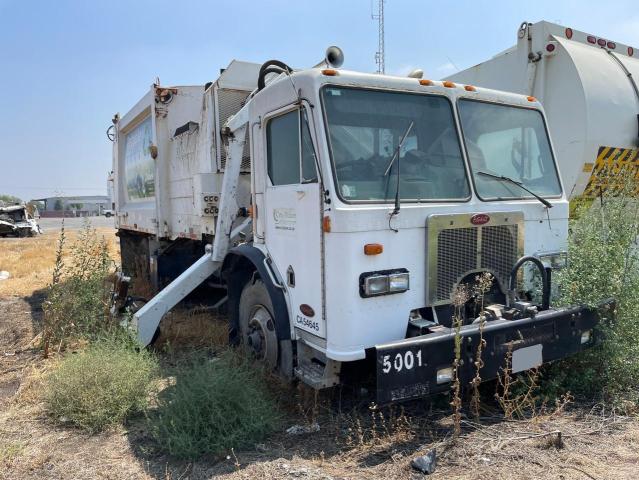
[{"left": 447, "top": 21, "right": 639, "bottom": 198}]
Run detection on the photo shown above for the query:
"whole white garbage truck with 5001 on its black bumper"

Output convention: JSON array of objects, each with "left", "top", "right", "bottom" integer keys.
[{"left": 109, "top": 48, "right": 601, "bottom": 403}]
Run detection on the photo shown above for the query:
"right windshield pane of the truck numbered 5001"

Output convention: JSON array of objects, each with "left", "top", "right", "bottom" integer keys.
[{"left": 459, "top": 99, "right": 561, "bottom": 200}]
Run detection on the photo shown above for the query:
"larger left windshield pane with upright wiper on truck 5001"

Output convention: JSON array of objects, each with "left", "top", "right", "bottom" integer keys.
[{"left": 322, "top": 86, "right": 470, "bottom": 202}]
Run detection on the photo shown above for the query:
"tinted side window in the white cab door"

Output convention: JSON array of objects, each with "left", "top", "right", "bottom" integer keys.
[{"left": 266, "top": 110, "right": 317, "bottom": 186}]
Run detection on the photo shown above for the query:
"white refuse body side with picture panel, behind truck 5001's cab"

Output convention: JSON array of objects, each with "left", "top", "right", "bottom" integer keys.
[{"left": 114, "top": 62, "right": 259, "bottom": 240}]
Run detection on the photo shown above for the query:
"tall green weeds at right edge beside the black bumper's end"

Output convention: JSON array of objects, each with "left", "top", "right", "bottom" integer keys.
[{"left": 549, "top": 191, "right": 639, "bottom": 403}]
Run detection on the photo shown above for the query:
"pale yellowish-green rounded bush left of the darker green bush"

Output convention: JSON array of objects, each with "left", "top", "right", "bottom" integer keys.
[{"left": 44, "top": 339, "right": 158, "bottom": 432}]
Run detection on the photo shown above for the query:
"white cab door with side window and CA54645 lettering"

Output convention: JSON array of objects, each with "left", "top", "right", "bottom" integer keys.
[{"left": 264, "top": 106, "right": 326, "bottom": 338}]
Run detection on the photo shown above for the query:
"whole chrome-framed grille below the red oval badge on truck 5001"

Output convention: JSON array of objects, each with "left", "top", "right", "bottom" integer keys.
[{"left": 427, "top": 212, "right": 524, "bottom": 305}]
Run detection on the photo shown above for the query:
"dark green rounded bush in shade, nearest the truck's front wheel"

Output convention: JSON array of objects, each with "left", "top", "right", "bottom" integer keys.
[{"left": 148, "top": 351, "right": 279, "bottom": 459}]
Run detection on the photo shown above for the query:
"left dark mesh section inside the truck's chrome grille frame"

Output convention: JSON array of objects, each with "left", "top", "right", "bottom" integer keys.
[{"left": 437, "top": 227, "right": 477, "bottom": 300}]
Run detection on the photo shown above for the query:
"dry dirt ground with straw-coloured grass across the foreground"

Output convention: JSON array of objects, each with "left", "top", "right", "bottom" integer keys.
[{"left": 0, "top": 229, "right": 639, "bottom": 480}]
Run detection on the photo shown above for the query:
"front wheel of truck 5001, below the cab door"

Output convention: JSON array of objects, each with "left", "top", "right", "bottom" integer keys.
[{"left": 239, "top": 279, "right": 279, "bottom": 370}]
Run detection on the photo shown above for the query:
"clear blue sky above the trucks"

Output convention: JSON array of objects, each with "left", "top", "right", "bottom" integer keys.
[{"left": 0, "top": 0, "right": 639, "bottom": 200}]
